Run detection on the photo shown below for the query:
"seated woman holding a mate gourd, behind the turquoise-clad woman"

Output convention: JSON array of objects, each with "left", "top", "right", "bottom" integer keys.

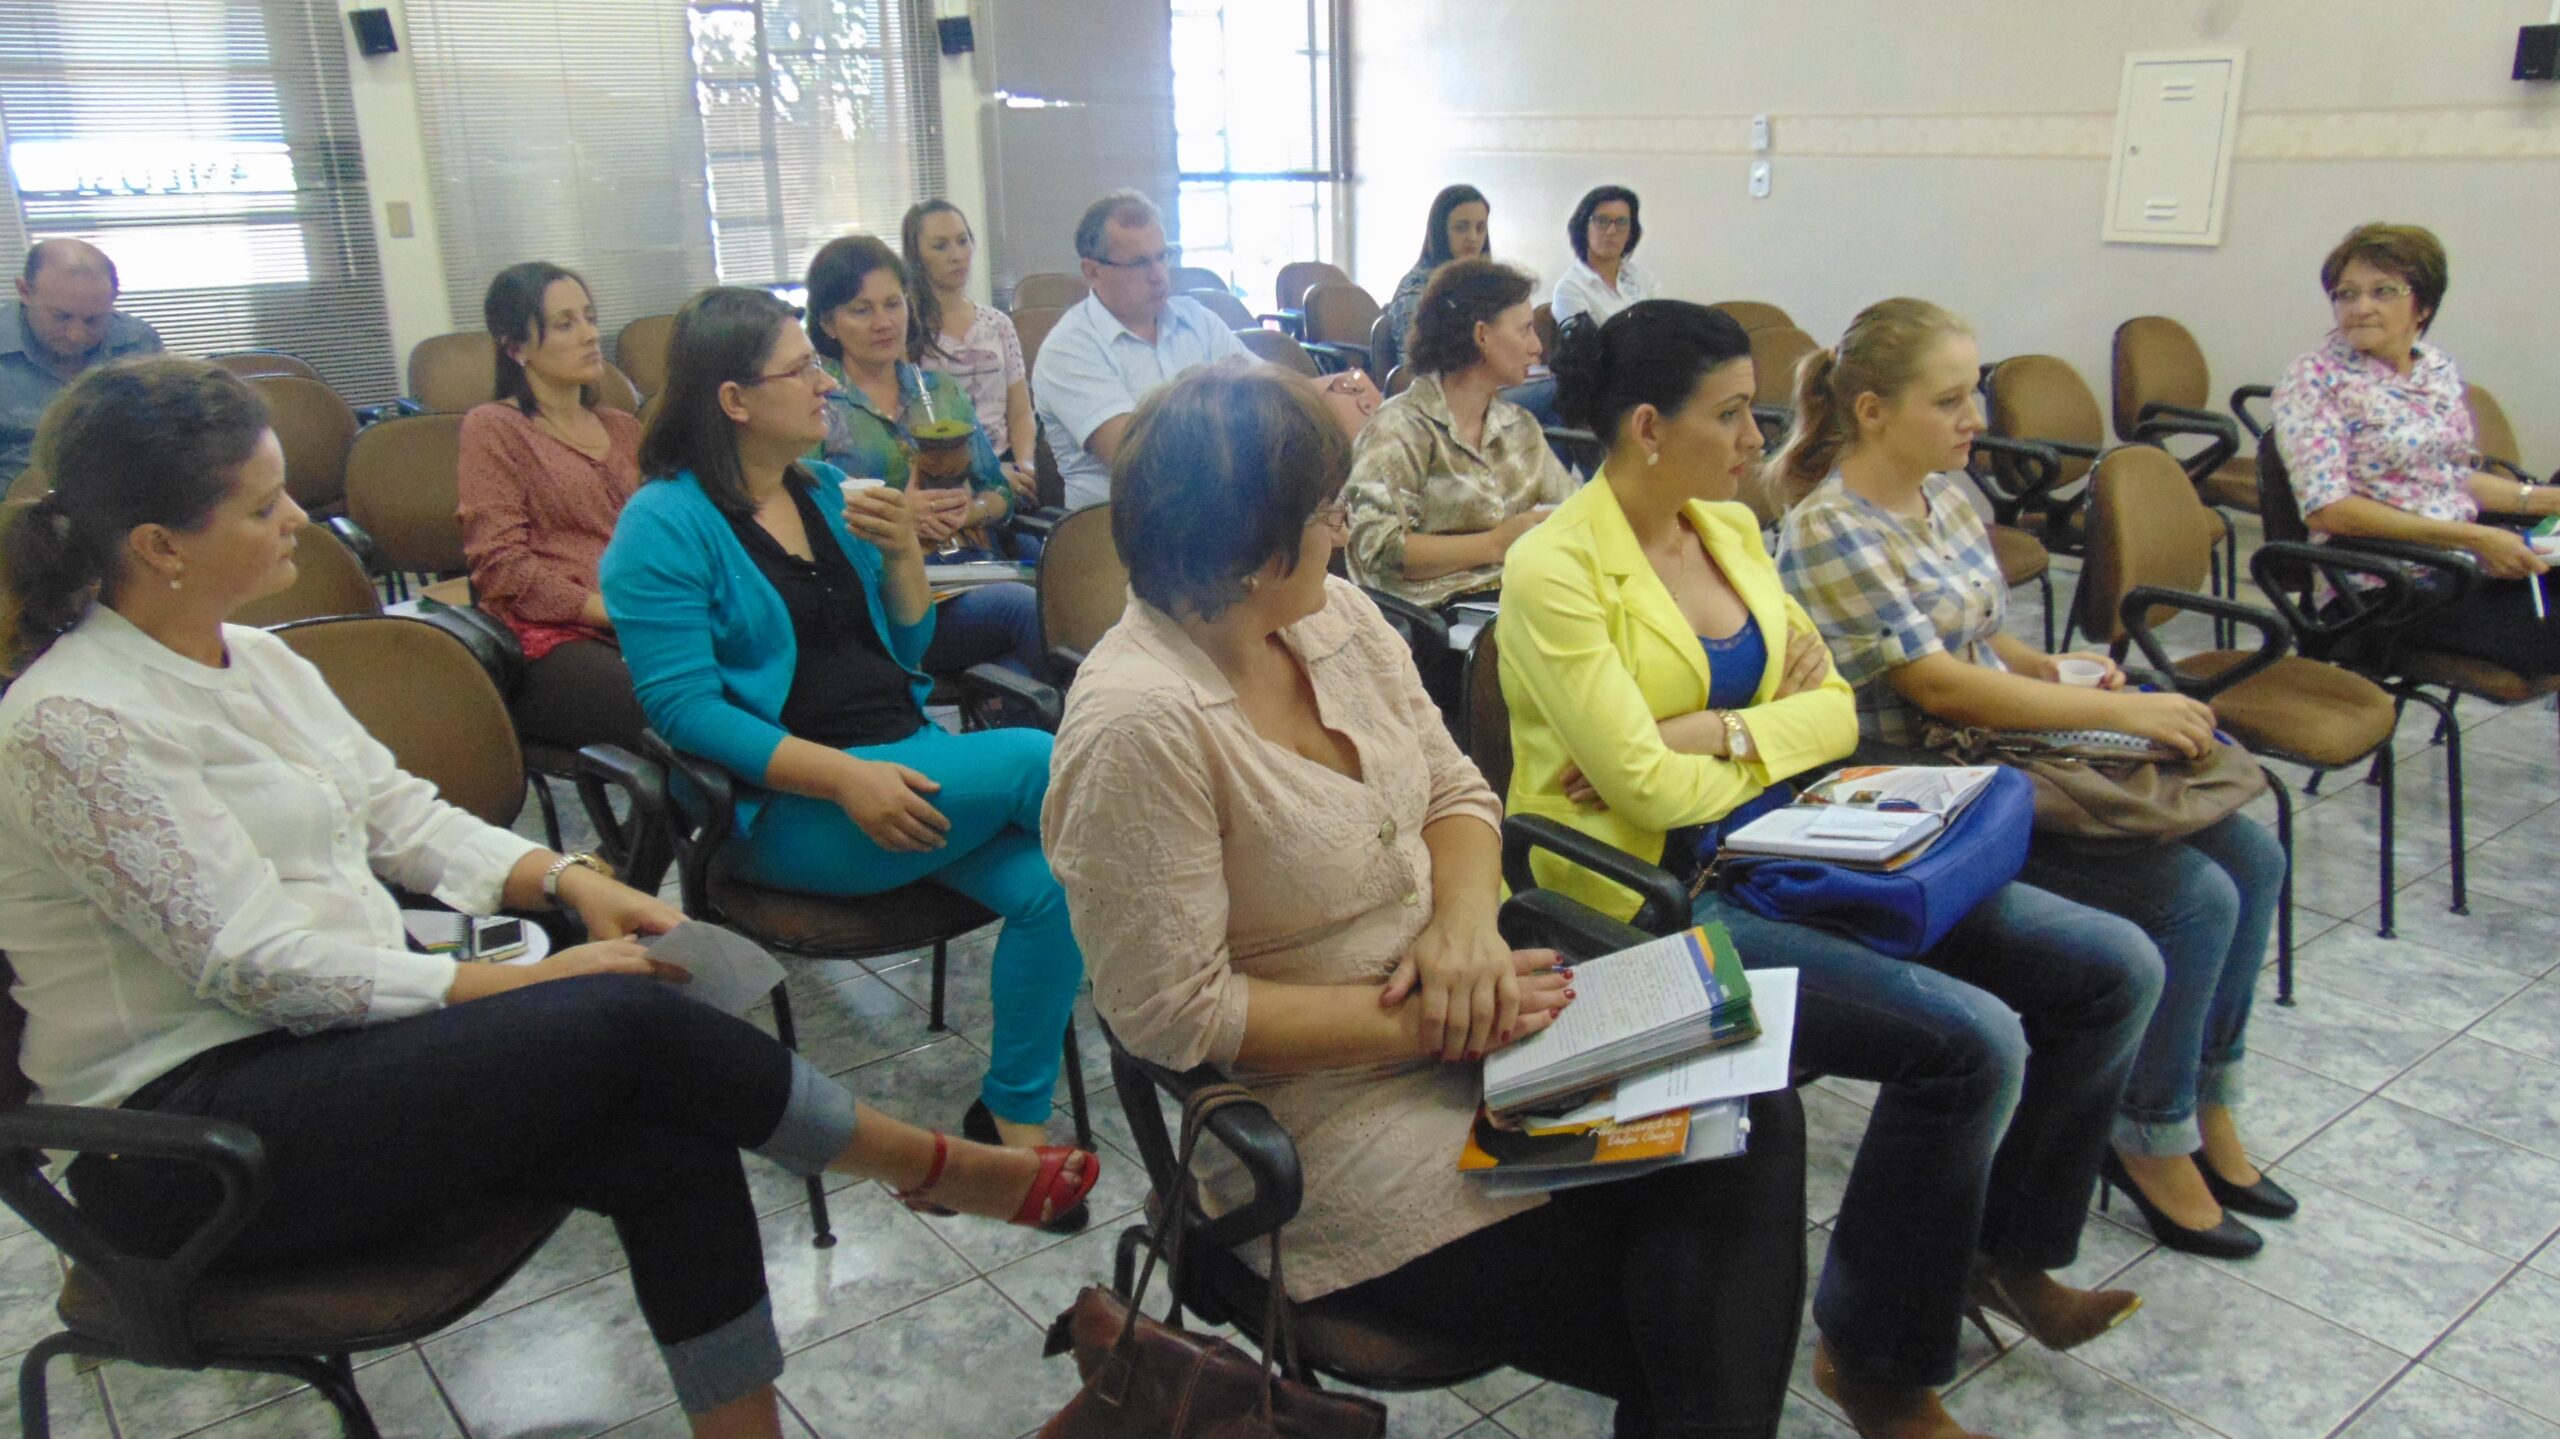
[{"left": 809, "top": 236, "right": 1039, "bottom": 673}]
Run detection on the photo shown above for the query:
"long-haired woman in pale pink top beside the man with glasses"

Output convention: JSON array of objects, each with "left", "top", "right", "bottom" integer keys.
[{"left": 899, "top": 200, "right": 1039, "bottom": 504}]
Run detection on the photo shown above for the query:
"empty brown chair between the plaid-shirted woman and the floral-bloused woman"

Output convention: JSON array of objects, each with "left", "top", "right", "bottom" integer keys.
[{"left": 2074, "top": 446, "right": 2399, "bottom": 983}]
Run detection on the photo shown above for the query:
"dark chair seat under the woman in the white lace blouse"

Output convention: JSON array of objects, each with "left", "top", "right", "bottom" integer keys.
[{"left": 59, "top": 1201, "right": 568, "bottom": 1355}]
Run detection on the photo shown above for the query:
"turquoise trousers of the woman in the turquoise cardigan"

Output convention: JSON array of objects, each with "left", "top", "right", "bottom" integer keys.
[{"left": 735, "top": 725, "right": 1085, "bottom": 1124}]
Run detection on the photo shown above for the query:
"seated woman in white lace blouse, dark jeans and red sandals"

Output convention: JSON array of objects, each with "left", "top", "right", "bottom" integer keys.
[{"left": 0, "top": 358, "right": 1098, "bottom": 1436}]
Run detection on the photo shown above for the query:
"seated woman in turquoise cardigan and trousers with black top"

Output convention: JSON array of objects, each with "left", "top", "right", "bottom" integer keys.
[{"left": 604, "top": 289, "right": 1083, "bottom": 1193}]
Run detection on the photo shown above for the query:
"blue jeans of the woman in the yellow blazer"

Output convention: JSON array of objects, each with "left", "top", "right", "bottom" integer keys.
[{"left": 1697, "top": 883, "right": 2161, "bottom": 1385}]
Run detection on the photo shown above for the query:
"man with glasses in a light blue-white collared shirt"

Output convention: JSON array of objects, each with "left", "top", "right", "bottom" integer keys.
[{"left": 1032, "top": 189, "right": 1247, "bottom": 510}]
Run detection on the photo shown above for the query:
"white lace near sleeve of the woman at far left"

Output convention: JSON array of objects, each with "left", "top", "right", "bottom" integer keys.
[{"left": 0, "top": 696, "right": 453, "bottom": 1034}]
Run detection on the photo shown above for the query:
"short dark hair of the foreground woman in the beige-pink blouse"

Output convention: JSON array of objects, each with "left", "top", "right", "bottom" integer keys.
[{"left": 1111, "top": 361, "right": 1352, "bottom": 620}]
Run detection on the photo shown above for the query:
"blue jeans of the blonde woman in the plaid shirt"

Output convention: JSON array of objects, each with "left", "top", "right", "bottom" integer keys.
[{"left": 2028, "top": 814, "right": 2284, "bottom": 1155}]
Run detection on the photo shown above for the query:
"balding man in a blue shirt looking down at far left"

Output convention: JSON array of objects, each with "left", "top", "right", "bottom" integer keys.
[{"left": 0, "top": 241, "right": 161, "bottom": 484}]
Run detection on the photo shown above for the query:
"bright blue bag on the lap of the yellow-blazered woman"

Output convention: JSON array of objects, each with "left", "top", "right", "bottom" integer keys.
[{"left": 1700, "top": 768, "right": 2035, "bottom": 960}]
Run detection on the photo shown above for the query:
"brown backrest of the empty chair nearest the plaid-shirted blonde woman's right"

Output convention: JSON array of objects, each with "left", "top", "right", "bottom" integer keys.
[{"left": 2074, "top": 446, "right": 2222, "bottom": 645}]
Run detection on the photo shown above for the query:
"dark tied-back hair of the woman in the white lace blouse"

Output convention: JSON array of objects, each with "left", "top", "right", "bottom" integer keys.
[{"left": 0, "top": 356, "right": 266, "bottom": 673}]
